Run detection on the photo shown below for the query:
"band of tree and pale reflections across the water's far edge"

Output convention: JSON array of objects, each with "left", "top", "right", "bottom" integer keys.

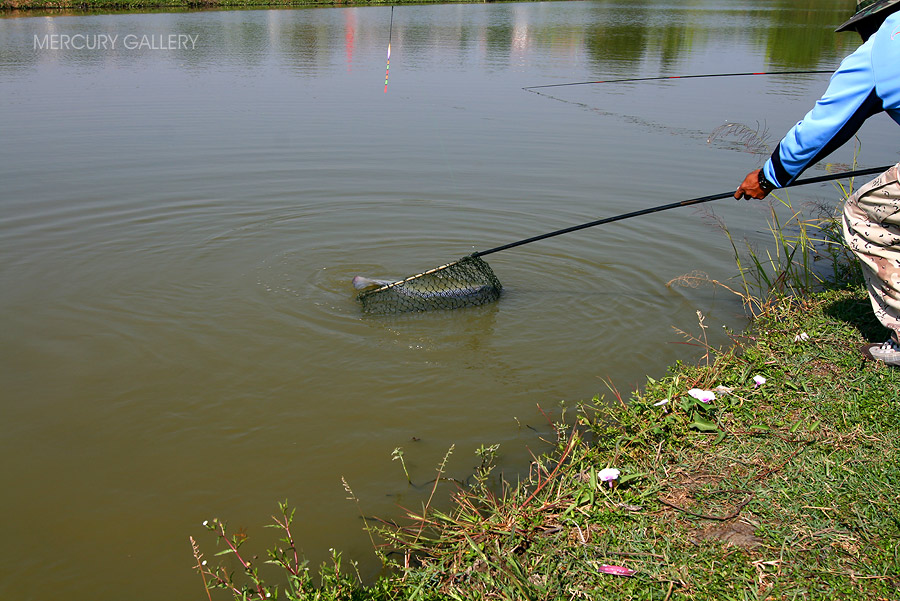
[{"left": 0, "top": 0, "right": 855, "bottom": 76}]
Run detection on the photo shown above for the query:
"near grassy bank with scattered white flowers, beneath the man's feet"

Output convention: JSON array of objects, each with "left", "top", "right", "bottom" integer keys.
[{"left": 197, "top": 288, "right": 900, "bottom": 601}]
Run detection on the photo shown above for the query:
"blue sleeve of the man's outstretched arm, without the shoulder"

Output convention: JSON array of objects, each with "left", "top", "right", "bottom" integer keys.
[{"left": 763, "top": 38, "right": 884, "bottom": 188}]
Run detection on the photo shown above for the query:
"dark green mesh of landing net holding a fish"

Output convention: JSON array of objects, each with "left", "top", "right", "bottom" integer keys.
[{"left": 356, "top": 255, "right": 503, "bottom": 314}]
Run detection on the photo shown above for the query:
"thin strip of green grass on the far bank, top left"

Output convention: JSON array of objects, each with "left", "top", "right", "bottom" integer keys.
[{"left": 0, "top": 0, "right": 506, "bottom": 12}]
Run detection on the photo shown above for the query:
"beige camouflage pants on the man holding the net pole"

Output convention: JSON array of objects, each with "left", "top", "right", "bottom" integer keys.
[{"left": 844, "top": 163, "right": 900, "bottom": 333}]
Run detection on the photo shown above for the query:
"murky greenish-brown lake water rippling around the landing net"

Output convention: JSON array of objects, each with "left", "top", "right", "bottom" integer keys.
[{"left": 0, "top": 0, "right": 897, "bottom": 601}]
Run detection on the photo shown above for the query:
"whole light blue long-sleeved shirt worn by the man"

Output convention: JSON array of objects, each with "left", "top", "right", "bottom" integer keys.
[{"left": 763, "top": 12, "right": 900, "bottom": 187}]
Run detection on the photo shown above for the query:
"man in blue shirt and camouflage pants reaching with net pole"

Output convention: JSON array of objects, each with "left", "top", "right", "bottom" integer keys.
[{"left": 734, "top": 0, "right": 900, "bottom": 365}]
